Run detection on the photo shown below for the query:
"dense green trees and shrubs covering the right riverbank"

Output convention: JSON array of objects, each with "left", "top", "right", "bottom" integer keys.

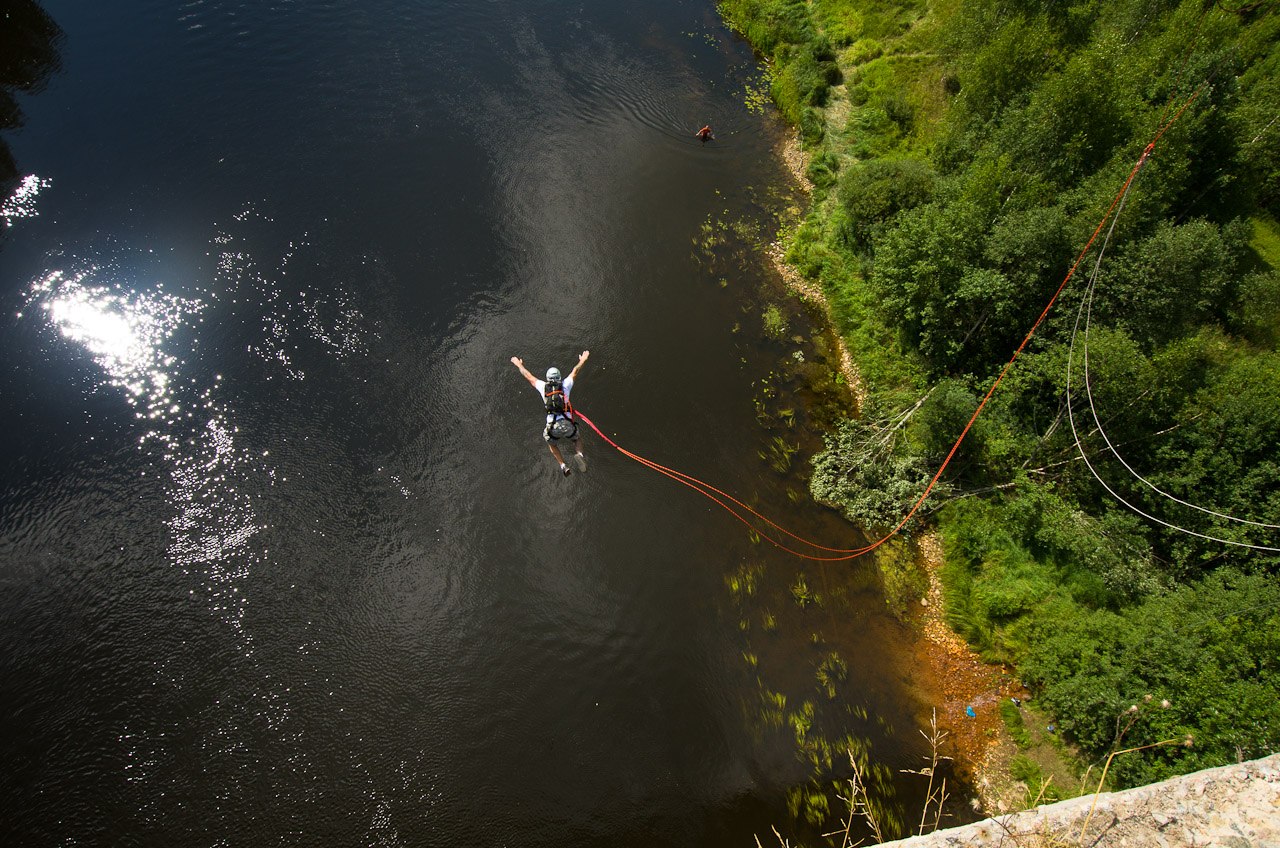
[{"left": 722, "top": 0, "right": 1280, "bottom": 784}]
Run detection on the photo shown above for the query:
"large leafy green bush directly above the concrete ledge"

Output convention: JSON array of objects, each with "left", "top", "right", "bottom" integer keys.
[{"left": 1020, "top": 570, "right": 1280, "bottom": 785}]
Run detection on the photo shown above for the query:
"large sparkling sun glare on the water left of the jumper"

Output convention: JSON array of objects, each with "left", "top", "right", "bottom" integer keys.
[{"left": 17, "top": 210, "right": 376, "bottom": 833}]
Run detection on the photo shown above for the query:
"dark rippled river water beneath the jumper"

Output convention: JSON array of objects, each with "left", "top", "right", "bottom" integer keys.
[{"left": 0, "top": 0, "right": 962, "bottom": 847}]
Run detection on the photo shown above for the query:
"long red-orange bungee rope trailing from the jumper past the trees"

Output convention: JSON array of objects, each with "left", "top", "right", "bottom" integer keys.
[{"left": 573, "top": 82, "right": 1208, "bottom": 562}]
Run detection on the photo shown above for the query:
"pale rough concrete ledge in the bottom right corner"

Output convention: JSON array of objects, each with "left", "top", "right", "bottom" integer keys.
[{"left": 884, "top": 754, "right": 1280, "bottom": 848}]
